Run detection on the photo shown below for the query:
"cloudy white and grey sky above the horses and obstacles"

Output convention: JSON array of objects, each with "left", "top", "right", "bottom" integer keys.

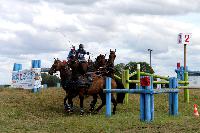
[{"left": 0, "top": 0, "right": 200, "bottom": 84}]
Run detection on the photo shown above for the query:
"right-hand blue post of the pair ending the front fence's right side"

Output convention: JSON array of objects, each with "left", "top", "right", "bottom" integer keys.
[{"left": 172, "top": 77, "right": 178, "bottom": 115}]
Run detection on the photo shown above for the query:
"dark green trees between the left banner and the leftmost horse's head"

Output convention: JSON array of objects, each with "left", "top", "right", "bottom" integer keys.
[{"left": 41, "top": 73, "right": 60, "bottom": 87}]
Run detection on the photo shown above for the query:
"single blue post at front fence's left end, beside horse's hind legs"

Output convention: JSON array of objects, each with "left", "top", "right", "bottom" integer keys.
[{"left": 106, "top": 77, "right": 111, "bottom": 117}]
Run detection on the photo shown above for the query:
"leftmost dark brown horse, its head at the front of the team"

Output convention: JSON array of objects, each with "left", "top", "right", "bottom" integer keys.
[{"left": 49, "top": 59, "right": 112, "bottom": 114}]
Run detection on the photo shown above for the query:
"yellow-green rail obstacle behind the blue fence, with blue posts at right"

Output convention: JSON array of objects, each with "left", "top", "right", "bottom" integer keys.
[{"left": 115, "top": 63, "right": 189, "bottom": 104}]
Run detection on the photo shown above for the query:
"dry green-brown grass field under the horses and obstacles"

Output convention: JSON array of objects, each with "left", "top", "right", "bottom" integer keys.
[{"left": 0, "top": 88, "right": 200, "bottom": 133}]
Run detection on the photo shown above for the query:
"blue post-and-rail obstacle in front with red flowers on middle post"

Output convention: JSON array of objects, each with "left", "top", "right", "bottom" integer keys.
[{"left": 104, "top": 77, "right": 179, "bottom": 122}]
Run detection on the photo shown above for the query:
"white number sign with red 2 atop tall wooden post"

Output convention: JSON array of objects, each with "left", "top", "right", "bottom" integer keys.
[{"left": 178, "top": 33, "right": 192, "bottom": 45}]
